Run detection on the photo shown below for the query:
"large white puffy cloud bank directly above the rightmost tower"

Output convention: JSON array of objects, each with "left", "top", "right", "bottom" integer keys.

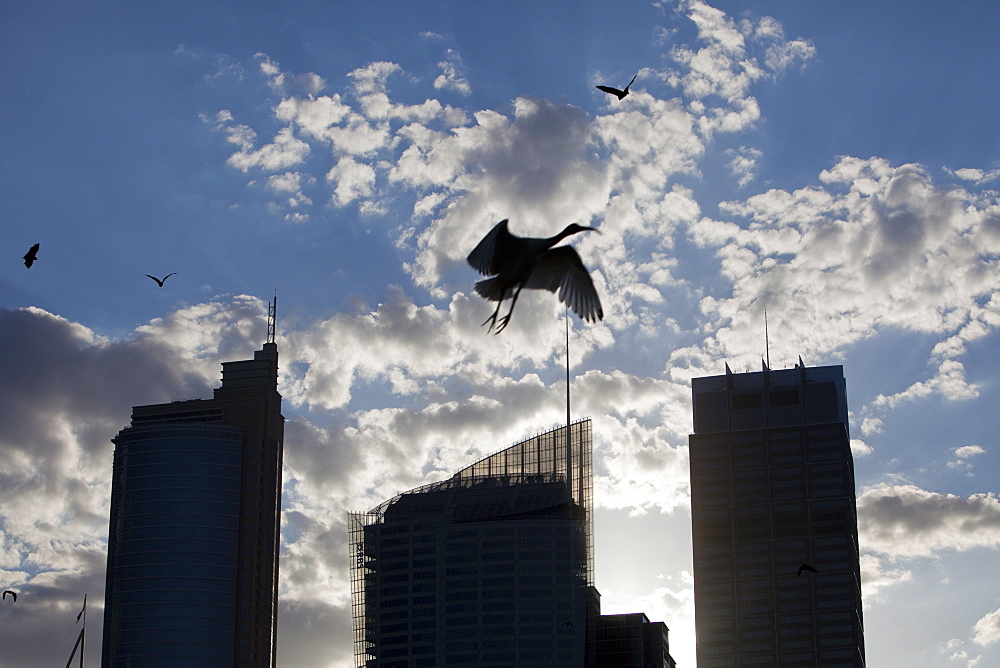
[{"left": 690, "top": 158, "right": 997, "bottom": 386}]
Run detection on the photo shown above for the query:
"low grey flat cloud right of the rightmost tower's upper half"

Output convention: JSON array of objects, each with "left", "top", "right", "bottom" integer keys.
[{"left": 858, "top": 484, "right": 1000, "bottom": 559}]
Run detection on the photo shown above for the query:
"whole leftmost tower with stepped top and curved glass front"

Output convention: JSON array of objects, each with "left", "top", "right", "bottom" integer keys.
[{"left": 101, "top": 336, "right": 284, "bottom": 668}]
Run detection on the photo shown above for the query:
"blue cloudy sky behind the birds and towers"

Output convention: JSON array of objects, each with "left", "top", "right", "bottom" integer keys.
[{"left": 0, "top": 0, "right": 1000, "bottom": 668}]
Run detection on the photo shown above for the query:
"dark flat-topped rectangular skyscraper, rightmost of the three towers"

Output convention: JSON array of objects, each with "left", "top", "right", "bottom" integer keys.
[{"left": 689, "top": 360, "right": 865, "bottom": 668}]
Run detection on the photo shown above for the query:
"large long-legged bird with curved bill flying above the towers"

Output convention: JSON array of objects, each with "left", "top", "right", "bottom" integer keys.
[{"left": 467, "top": 218, "right": 604, "bottom": 334}]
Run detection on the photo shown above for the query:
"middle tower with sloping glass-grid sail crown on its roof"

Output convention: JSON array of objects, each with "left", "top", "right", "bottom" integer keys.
[{"left": 350, "top": 420, "right": 600, "bottom": 668}]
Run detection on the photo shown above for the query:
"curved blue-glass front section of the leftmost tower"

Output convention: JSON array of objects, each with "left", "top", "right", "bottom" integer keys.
[{"left": 105, "top": 425, "right": 243, "bottom": 665}]
